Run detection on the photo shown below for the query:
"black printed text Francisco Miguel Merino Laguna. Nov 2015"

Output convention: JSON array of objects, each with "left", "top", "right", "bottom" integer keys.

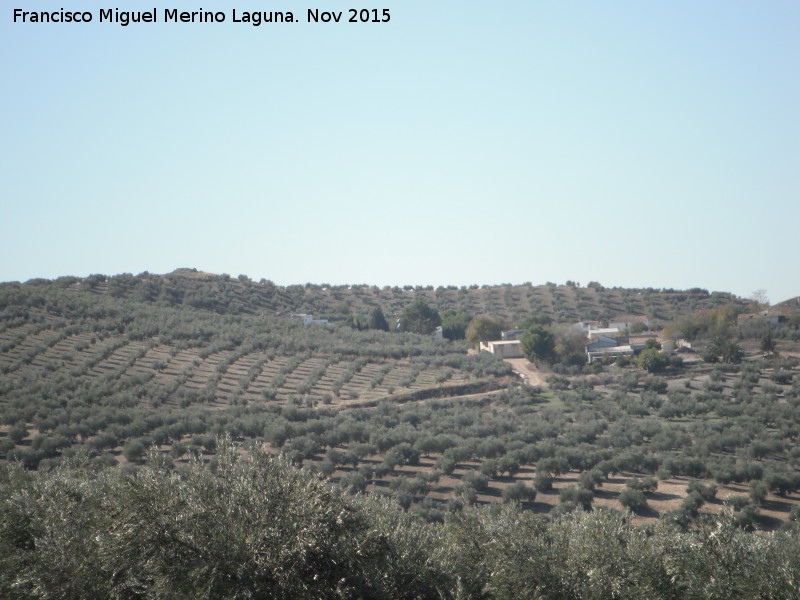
[{"left": 14, "top": 8, "right": 391, "bottom": 27}]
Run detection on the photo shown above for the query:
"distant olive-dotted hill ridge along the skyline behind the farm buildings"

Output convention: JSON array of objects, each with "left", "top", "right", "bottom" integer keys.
[{"left": 9, "top": 268, "right": 753, "bottom": 325}]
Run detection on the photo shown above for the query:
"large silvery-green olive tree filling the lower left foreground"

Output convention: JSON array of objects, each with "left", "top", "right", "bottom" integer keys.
[{"left": 0, "top": 448, "right": 448, "bottom": 600}]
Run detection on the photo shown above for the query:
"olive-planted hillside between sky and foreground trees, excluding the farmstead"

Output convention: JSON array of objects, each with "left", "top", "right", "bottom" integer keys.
[{"left": 0, "top": 270, "right": 800, "bottom": 529}]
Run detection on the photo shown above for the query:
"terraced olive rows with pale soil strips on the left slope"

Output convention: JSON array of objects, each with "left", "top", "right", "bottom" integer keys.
[{"left": 0, "top": 324, "right": 488, "bottom": 408}]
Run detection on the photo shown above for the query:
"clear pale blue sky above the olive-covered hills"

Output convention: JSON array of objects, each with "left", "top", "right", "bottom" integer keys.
[{"left": 0, "top": 0, "right": 800, "bottom": 303}]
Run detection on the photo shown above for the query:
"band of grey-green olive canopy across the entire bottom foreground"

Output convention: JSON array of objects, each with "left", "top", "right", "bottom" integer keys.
[{"left": 0, "top": 444, "right": 800, "bottom": 600}]
